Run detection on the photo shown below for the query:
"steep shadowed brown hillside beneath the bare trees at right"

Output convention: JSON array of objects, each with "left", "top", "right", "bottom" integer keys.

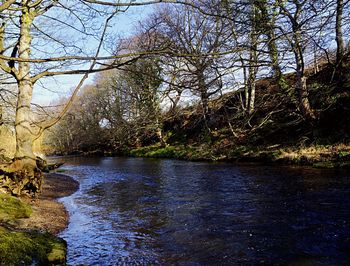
[{"left": 130, "top": 57, "right": 350, "bottom": 167}]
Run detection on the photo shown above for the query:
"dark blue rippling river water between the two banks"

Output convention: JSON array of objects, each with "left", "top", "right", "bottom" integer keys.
[{"left": 56, "top": 158, "right": 350, "bottom": 265}]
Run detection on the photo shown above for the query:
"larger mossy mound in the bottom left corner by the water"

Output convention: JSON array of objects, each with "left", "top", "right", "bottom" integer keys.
[{"left": 0, "top": 227, "right": 66, "bottom": 266}]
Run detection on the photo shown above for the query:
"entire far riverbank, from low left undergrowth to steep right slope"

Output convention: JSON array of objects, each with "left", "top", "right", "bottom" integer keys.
[{"left": 45, "top": 57, "right": 350, "bottom": 168}]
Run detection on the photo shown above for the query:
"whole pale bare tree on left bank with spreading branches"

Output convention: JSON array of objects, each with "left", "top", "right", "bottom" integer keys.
[{"left": 0, "top": 0, "right": 174, "bottom": 193}]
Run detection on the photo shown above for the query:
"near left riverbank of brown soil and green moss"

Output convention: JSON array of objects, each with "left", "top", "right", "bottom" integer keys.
[{"left": 0, "top": 173, "right": 79, "bottom": 265}]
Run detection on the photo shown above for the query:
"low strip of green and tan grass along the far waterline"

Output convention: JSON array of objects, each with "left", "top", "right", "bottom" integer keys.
[{"left": 129, "top": 143, "right": 350, "bottom": 168}]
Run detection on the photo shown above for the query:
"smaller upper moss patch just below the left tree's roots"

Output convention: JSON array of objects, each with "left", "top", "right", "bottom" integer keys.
[{"left": 0, "top": 194, "right": 32, "bottom": 223}]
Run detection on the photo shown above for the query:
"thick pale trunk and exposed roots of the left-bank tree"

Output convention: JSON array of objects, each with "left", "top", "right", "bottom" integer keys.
[{"left": 0, "top": 4, "right": 43, "bottom": 195}]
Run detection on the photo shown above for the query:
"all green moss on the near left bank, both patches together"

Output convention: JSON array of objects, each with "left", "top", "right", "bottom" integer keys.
[{"left": 0, "top": 194, "right": 66, "bottom": 266}]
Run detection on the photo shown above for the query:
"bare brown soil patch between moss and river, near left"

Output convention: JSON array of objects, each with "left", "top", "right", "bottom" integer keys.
[{"left": 18, "top": 173, "right": 79, "bottom": 235}]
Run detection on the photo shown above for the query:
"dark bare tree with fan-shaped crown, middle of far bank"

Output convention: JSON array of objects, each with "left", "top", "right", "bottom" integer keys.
[{"left": 152, "top": 2, "right": 230, "bottom": 130}]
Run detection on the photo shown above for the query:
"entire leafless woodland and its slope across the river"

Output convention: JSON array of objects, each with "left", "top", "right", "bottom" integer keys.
[{"left": 43, "top": 1, "right": 350, "bottom": 167}]
